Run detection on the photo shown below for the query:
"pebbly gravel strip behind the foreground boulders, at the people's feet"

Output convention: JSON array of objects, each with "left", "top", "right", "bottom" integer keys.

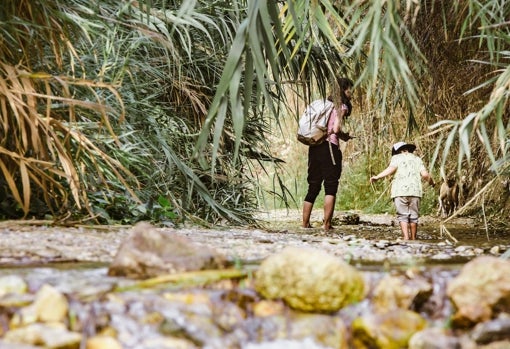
[{"left": 0, "top": 210, "right": 510, "bottom": 265}]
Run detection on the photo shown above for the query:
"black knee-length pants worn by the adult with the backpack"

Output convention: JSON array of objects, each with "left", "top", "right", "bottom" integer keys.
[{"left": 305, "top": 142, "right": 342, "bottom": 203}]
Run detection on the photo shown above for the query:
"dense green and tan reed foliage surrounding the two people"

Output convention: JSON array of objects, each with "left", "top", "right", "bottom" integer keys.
[{"left": 0, "top": 0, "right": 510, "bottom": 223}]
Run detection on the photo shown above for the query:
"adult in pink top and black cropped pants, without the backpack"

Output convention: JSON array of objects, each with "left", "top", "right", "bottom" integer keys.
[{"left": 302, "top": 78, "right": 353, "bottom": 231}]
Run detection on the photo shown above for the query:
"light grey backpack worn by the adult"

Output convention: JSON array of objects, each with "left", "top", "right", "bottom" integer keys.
[{"left": 297, "top": 99, "right": 335, "bottom": 146}]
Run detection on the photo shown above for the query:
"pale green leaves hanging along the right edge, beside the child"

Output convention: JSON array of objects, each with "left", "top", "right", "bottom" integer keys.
[{"left": 431, "top": 1, "right": 510, "bottom": 174}]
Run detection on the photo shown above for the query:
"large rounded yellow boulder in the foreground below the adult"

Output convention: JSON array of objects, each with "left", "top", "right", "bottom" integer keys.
[{"left": 255, "top": 247, "right": 365, "bottom": 312}]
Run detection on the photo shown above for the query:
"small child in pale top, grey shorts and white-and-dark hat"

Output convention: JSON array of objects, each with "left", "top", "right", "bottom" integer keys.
[{"left": 370, "top": 142, "right": 435, "bottom": 240}]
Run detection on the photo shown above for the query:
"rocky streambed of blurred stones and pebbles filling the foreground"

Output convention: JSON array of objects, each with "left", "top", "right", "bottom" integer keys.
[{"left": 0, "top": 213, "right": 510, "bottom": 349}]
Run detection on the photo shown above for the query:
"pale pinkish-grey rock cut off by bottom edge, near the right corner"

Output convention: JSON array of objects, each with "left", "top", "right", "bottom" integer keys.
[{"left": 409, "top": 328, "right": 477, "bottom": 349}]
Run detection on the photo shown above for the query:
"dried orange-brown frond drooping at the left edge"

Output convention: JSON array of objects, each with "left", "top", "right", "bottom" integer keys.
[{"left": 0, "top": 63, "right": 136, "bottom": 215}]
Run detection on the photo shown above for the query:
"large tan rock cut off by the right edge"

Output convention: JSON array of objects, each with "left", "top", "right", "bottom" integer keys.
[{"left": 447, "top": 256, "right": 510, "bottom": 327}]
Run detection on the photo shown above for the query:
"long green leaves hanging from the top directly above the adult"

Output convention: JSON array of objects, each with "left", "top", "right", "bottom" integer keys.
[{"left": 195, "top": 1, "right": 347, "bottom": 170}]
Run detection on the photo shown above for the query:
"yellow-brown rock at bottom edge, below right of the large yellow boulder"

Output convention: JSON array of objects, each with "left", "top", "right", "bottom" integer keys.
[{"left": 352, "top": 309, "right": 427, "bottom": 349}]
